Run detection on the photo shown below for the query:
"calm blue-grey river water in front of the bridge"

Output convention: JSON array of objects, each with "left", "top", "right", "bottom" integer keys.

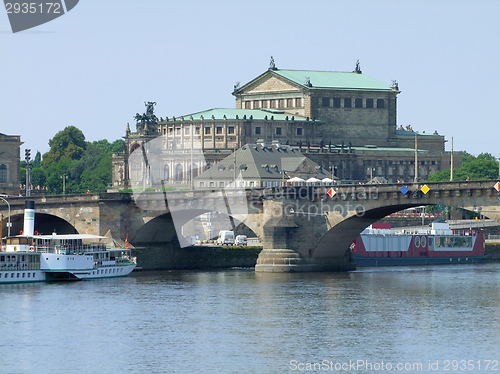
[{"left": 0, "top": 264, "right": 500, "bottom": 374}]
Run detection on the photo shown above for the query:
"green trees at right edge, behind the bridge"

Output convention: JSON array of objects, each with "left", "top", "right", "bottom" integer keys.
[{"left": 428, "top": 153, "right": 498, "bottom": 182}]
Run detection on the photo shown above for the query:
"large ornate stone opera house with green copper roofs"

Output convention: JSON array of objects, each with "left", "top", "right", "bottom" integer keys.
[{"left": 113, "top": 60, "right": 460, "bottom": 190}]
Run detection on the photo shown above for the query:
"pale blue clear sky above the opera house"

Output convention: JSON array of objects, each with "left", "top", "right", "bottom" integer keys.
[{"left": 0, "top": 0, "right": 500, "bottom": 157}]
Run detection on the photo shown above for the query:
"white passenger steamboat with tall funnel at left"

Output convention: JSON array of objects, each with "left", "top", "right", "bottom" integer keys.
[{"left": 0, "top": 201, "right": 137, "bottom": 284}]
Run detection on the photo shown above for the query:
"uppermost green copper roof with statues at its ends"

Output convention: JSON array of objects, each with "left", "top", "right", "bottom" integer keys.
[{"left": 272, "top": 70, "right": 393, "bottom": 91}]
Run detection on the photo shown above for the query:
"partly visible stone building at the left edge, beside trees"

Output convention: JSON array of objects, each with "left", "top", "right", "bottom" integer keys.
[{"left": 0, "top": 133, "right": 23, "bottom": 196}]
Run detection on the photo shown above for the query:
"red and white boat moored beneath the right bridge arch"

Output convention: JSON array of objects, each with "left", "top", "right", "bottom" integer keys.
[{"left": 351, "top": 222, "right": 484, "bottom": 267}]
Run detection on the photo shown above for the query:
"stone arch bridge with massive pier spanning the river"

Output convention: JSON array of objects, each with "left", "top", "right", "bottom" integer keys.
[{"left": 0, "top": 180, "right": 500, "bottom": 272}]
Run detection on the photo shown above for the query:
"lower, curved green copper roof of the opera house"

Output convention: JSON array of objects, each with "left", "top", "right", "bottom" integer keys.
[{"left": 163, "top": 108, "right": 307, "bottom": 122}]
